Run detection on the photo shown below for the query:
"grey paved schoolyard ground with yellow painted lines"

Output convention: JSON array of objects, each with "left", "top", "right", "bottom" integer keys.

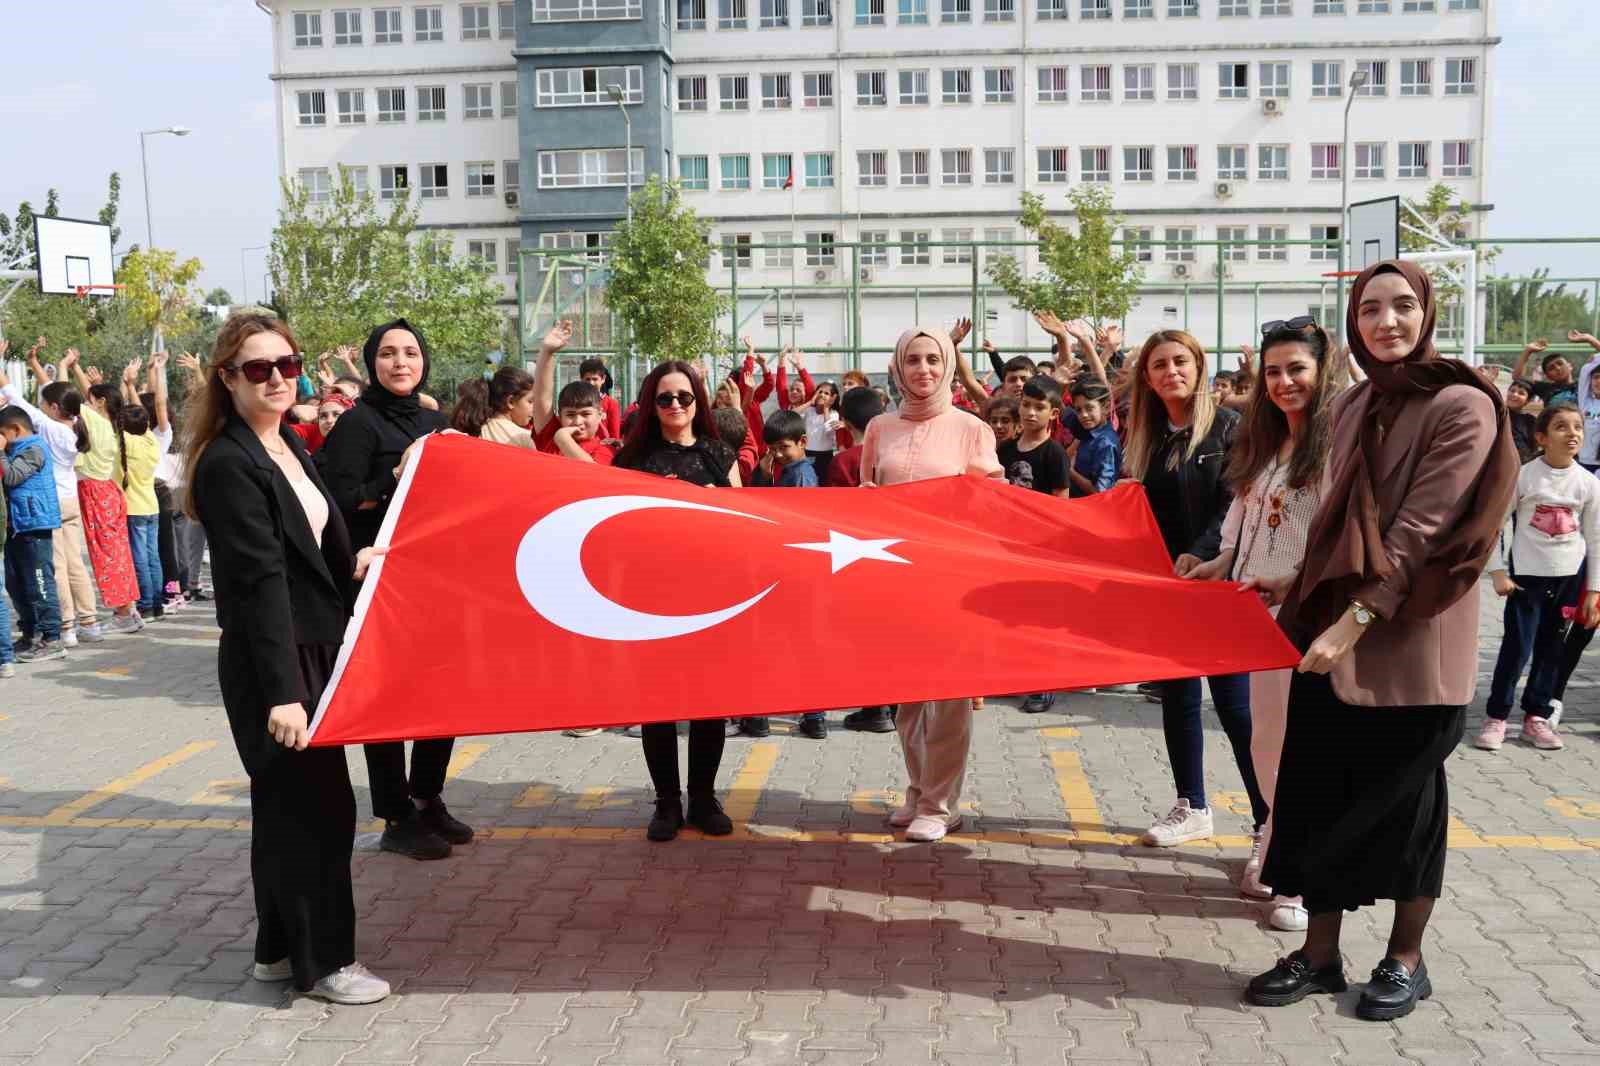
[{"left": 0, "top": 582, "right": 1600, "bottom": 1066}]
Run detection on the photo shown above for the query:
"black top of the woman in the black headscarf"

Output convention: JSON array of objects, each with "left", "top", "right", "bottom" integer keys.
[{"left": 317, "top": 396, "right": 448, "bottom": 549}]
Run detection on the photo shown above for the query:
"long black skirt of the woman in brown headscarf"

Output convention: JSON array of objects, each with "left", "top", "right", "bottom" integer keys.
[{"left": 1261, "top": 674, "right": 1466, "bottom": 914}]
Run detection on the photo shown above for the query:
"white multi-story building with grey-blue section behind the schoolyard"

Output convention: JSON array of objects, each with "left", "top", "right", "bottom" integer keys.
[{"left": 256, "top": 0, "right": 1496, "bottom": 361}]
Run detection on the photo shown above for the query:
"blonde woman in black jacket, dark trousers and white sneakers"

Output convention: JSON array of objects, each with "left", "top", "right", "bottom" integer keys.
[{"left": 1125, "top": 330, "right": 1267, "bottom": 848}]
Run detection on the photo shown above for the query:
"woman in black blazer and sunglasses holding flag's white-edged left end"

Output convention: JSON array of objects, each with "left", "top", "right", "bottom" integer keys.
[{"left": 186, "top": 315, "right": 389, "bottom": 1004}]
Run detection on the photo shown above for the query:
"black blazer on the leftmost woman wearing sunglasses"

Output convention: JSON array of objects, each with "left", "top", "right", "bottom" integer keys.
[{"left": 192, "top": 418, "right": 355, "bottom": 776}]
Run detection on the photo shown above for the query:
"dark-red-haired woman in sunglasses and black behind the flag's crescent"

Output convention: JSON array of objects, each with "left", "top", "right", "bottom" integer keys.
[{"left": 614, "top": 362, "right": 739, "bottom": 840}]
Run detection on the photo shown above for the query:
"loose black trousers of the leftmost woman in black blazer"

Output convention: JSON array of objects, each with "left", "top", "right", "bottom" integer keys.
[{"left": 250, "top": 645, "right": 355, "bottom": 992}]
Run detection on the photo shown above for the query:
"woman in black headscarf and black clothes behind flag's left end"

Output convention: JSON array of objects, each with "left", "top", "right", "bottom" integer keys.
[{"left": 317, "top": 319, "right": 472, "bottom": 860}]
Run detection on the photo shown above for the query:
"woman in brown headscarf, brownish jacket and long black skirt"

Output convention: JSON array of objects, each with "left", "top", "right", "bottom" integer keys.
[{"left": 1250, "top": 261, "right": 1517, "bottom": 1021}]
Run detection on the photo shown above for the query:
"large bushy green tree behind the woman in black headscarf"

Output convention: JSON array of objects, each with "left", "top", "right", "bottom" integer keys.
[{"left": 267, "top": 172, "right": 504, "bottom": 381}]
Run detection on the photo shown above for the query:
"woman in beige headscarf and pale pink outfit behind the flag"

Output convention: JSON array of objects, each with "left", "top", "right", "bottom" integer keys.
[{"left": 861, "top": 327, "right": 1002, "bottom": 840}]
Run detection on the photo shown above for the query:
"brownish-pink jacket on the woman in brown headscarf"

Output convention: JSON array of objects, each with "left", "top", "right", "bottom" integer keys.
[{"left": 1323, "top": 383, "right": 1498, "bottom": 707}]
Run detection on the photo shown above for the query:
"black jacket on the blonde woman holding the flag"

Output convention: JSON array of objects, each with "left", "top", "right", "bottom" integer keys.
[{"left": 1144, "top": 408, "right": 1238, "bottom": 560}]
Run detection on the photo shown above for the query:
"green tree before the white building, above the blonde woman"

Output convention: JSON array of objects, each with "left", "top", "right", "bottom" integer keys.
[{"left": 989, "top": 184, "right": 1144, "bottom": 323}]
